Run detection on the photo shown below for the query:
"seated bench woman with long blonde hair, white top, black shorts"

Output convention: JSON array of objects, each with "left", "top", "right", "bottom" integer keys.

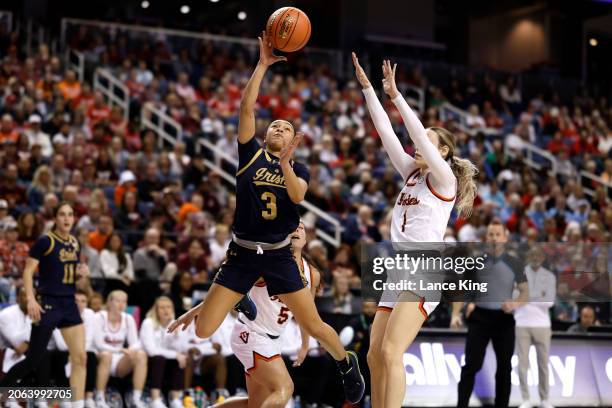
[{"left": 140, "top": 296, "right": 187, "bottom": 408}]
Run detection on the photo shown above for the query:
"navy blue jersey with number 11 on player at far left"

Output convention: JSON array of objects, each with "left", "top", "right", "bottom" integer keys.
[{"left": 30, "top": 231, "right": 81, "bottom": 296}]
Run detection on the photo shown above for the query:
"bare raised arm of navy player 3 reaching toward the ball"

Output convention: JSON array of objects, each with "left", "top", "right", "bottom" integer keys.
[{"left": 238, "top": 31, "right": 287, "bottom": 143}]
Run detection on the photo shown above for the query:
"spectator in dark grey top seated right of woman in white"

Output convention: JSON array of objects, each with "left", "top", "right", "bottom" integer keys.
[{"left": 134, "top": 228, "right": 168, "bottom": 282}]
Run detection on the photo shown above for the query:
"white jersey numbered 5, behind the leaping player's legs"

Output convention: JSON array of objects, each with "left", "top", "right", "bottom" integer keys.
[{"left": 240, "top": 259, "right": 312, "bottom": 336}]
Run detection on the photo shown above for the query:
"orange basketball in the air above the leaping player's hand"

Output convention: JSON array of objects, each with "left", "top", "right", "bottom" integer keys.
[{"left": 266, "top": 7, "right": 311, "bottom": 52}]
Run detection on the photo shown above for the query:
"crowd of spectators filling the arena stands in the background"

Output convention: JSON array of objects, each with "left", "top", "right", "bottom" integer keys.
[{"left": 0, "top": 23, "right": 612, "bottom": 408}]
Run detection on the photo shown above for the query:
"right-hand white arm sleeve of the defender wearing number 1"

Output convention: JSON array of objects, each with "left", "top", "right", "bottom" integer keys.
[{"left": 393, "top": 95, "right": 455, "bottom": 195}]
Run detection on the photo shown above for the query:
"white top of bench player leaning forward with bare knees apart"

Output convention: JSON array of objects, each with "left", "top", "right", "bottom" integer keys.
[{"left": 94, "top": 310, "right": 140, "bottom": 352}]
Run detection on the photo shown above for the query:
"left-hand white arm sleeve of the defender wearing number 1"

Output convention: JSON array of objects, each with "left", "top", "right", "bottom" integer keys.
[{"left": 363, "top": 87, "right": 415, "bottom": 180}]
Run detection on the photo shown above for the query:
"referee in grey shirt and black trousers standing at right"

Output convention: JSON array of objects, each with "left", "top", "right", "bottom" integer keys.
[{"left": 451, "top": 220, "right": 529, "bottom": 408}]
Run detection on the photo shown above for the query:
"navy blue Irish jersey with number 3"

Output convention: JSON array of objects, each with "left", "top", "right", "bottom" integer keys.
[{"left": 233, "top": 138, "right": 310, "bottom": 243}]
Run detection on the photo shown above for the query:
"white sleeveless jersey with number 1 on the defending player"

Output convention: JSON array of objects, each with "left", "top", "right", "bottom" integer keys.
[{"left": 391, "top": 169, "right": 456, "bottom": 242}]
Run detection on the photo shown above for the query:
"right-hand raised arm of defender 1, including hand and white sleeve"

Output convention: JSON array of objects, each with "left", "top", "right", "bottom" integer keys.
[{"left": 382, "top": 60, "right": 455, "bottom": 185}]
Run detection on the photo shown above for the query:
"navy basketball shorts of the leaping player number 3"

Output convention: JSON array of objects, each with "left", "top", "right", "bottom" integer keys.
[{"left": 214, "top": 241, "right": 306, "bottom": 296}]
